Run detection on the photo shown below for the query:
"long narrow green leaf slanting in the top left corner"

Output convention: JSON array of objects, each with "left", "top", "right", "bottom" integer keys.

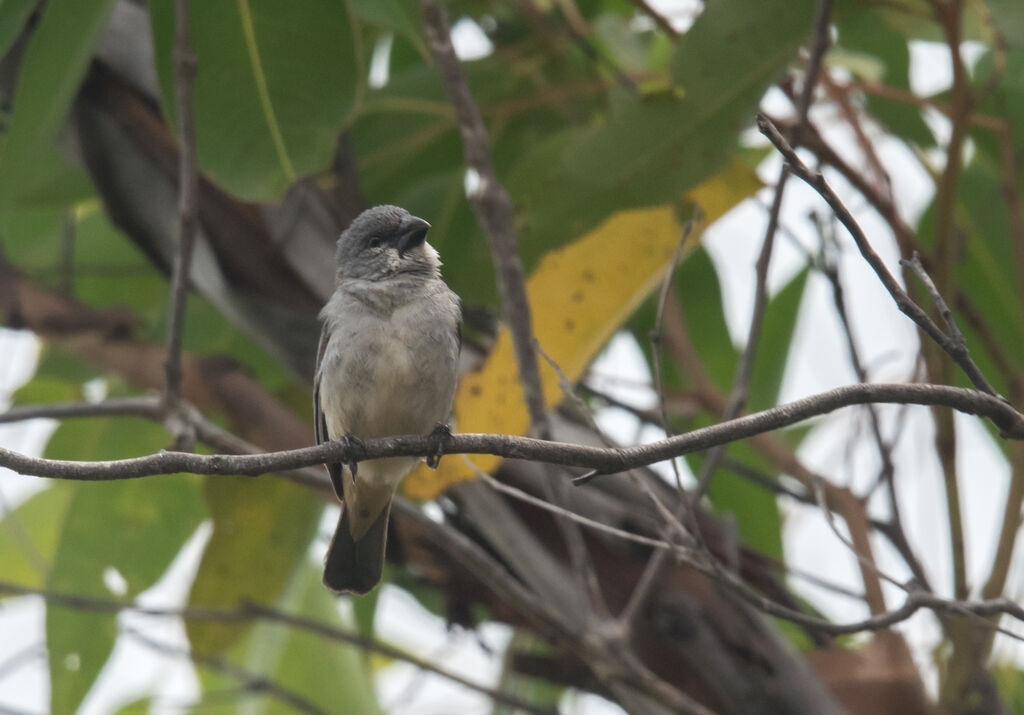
[{"left": 0, "top": 0, "right": 114, "bottom": 205}]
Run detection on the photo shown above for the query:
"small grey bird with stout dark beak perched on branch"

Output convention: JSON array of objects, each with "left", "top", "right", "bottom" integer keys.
[{"left": 313, "top": 206, "right": 462, "bottom": 593}]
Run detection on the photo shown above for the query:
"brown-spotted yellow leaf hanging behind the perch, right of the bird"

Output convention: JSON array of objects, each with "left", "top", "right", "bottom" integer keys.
[{"left": 403, "top": 163, "right": 761, "bottom": 500}]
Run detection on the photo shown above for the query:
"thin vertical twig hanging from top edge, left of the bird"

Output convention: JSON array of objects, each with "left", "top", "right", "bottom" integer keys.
[{"left": 164, "top": 0, "right": 199, "bottom": 408}]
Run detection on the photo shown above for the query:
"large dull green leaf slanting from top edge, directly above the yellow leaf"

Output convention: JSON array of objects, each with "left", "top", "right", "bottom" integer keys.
[{"left": 508, "top": 0, "right": 813, "bottom": 264}]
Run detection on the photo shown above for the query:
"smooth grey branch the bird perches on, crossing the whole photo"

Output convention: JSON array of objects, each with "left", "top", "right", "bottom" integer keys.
[{"left": 0, "top": 383, "right": 1024, "bottom": 481}]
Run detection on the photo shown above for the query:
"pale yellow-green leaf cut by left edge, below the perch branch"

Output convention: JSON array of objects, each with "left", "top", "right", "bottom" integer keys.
[{"left": 0, "top": 482, "right": 74, "bottom": 588}]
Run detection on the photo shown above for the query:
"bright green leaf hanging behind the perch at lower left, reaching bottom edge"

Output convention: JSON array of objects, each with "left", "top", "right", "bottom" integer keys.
[{"left": 46, "top": 419, "right": 204, "bottom": 713}]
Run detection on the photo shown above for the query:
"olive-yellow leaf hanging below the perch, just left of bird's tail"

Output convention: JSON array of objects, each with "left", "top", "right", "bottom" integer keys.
[{"left": 186, "top": 476, "right": 324, "bottom": 655}]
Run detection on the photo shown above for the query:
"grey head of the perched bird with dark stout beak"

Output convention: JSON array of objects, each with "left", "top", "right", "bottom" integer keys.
[{"left": 338, "top": 205, "right": 440, "bottom": 281}]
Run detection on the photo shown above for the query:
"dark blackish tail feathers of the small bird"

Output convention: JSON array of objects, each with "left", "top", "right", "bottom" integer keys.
[{"left": 324, "top": 503, "right": 391, "bottom": 594}]
